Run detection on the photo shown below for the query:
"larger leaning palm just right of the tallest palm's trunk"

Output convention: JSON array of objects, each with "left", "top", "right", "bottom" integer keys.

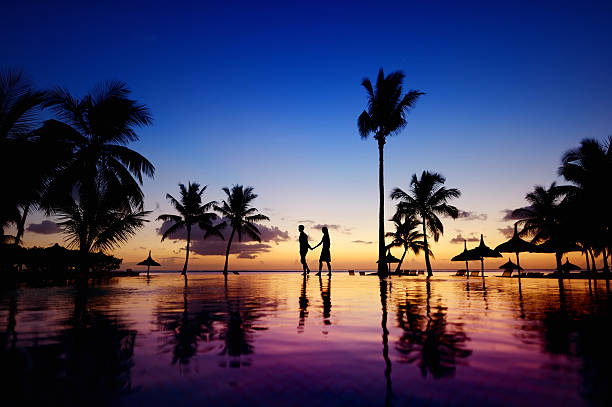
[{"left": 391, "top": 171, "right": 461, "bottom": 277}]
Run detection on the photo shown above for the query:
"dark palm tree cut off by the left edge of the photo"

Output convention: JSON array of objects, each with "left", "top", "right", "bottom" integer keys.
[{"left": 0, "top": 69, "right": 48, "bottom": 237}]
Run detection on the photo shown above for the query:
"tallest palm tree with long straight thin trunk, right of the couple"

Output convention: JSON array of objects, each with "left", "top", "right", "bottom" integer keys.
[{"left": 357, "top": 68, "right": 424, "bottom": 275}]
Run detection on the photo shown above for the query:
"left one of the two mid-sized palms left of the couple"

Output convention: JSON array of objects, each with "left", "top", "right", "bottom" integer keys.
[{"left": 157, "top": 182, "right": 225, "bottom": 278}]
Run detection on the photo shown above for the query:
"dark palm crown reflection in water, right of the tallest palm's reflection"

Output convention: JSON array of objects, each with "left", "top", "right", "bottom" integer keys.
[{"left": 396, "top": 281, "right": 472, "bottom": 379}]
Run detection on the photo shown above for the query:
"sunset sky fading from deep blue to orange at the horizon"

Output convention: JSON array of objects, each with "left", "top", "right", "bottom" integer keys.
[{"left": 0, "top": 1, "right": 612, "bottom": 270}]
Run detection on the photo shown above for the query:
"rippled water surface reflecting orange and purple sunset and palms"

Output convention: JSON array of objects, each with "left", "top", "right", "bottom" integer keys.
[{"left": 0, "top": 273, "right": 612, "bottom": 406}]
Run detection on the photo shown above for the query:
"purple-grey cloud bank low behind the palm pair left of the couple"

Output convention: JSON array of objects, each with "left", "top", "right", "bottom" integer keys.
[{"left": 157, "top": 222, "right": 289, "bottom": 259}]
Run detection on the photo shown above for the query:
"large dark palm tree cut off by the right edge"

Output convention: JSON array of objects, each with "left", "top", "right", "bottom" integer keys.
[{"left": 559, "top": 136, "right": 612, "bottom": 271}]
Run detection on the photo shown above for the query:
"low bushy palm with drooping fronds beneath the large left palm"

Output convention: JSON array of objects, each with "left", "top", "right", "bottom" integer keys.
[{"left": 54, "top": 182, "right": 151, "bottom": 271}]
